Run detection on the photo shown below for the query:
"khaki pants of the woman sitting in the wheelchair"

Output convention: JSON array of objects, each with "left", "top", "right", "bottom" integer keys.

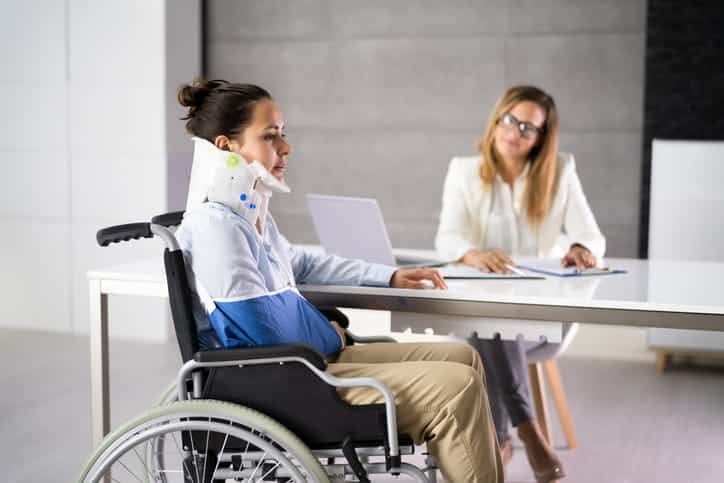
[{"left": 328, "top": 343, "right": 503, "bottom": 483}]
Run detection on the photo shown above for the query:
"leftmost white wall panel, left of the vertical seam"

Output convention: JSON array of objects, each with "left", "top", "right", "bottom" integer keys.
[{"left": 0, "top": 1, "right": 71, "bottom": 330}]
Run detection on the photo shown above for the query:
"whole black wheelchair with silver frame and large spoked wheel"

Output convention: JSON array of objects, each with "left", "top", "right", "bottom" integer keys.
[{"left": 79, "top": 211, "right": 437, "bottom": 483}]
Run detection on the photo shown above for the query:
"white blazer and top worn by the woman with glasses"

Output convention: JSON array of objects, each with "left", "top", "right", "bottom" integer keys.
[{"left": 435, "top": 153, "right": 606, "bottom": 260}]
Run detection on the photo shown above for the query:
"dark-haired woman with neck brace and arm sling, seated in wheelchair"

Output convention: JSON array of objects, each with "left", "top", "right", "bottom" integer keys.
[{"left": 164, "top": 80, "right": 503, "bottom": 483}]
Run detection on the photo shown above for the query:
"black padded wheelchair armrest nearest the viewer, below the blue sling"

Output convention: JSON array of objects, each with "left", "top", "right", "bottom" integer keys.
[{"left": 194, "top": 344, "right": 327, "bottom": 371}]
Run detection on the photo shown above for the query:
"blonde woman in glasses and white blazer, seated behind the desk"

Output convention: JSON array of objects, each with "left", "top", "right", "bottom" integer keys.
[{"left": 435, "top": 86, "right": 606, "bottom": 482}]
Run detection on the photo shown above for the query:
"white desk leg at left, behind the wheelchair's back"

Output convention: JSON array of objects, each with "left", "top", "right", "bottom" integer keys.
[{"left": 90, "top": 280, "right": 111, "bottom": 448}]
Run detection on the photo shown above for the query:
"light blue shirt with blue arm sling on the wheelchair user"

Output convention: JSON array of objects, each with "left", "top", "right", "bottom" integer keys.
[{"left": 176, "top": 202, "right": 396, "bottom": 355}]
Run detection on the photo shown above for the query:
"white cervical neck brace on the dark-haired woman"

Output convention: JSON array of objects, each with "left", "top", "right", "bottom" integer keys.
[{"left": 186, "top": 137, "right": 290, "bottom": 236}]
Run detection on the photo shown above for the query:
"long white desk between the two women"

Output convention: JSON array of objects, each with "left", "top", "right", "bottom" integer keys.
[{"left": 88, "top": 256, "right": 724, "bottom": 445}]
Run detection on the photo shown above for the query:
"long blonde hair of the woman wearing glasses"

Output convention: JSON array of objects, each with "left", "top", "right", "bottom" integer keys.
[{"left": 478, "top": 86, "right": 558, "bottom": 225}]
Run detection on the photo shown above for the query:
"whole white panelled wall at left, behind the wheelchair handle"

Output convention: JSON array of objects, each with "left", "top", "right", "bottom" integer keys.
[{"left": 0, "top": 0, "right": 200, "bottom": 339}]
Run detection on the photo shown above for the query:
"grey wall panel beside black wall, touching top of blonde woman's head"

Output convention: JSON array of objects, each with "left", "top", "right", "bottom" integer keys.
[{"left": 505, "top": 34, "right": 644, "bottom": 131}]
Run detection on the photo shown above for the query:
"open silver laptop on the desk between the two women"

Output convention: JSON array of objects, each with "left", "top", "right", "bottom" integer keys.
[{"left": 307, "top": 194, "right": 442, "bottom": 267}]
